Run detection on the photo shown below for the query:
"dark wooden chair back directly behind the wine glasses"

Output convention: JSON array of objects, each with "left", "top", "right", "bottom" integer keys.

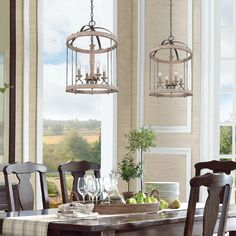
[{"left": 58, "top": 161, "right": 100, "bottom": 203}]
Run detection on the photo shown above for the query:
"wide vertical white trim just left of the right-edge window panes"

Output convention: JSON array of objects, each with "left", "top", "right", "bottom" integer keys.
[{"left": 200, "top": 0, "right": 220, "bottom": 161}]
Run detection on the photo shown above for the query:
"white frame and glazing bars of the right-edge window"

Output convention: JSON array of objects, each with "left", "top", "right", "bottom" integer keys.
[{"left": 200, "top": 0, "right": 236, "bottom": 201}]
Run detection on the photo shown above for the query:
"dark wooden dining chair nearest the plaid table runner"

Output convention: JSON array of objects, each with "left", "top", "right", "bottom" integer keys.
[{"left": 3, "top": 162, "right": 49, "bottom": 211}]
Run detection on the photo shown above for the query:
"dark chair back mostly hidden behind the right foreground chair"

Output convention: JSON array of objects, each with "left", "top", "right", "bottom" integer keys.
[{"left": 194, "top": 160, "right": 236, "bottom": 203}]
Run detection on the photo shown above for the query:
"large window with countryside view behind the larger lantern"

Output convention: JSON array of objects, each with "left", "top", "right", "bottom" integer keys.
[{"left": 42, "top": 0, "right": 116, "bottom": 205}]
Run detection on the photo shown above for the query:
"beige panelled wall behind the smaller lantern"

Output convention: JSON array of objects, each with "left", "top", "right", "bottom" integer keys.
[{"left": 118, "top": 0, "right": 200, "bottom": 200}]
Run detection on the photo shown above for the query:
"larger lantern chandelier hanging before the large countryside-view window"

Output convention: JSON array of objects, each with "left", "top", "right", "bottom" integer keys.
[{"left": 66, "top": 0, "right": 118, "bottom": 94}]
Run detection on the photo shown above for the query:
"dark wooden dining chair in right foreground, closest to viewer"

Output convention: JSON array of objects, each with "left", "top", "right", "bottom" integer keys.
[{"left": 184, "top": 173, "right": 233, "bottom": 236}]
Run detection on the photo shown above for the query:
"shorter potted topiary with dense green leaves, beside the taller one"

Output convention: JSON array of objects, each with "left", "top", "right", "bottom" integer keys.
[{"left": 118, "top": 153, "right": 143, "bottom": 198}]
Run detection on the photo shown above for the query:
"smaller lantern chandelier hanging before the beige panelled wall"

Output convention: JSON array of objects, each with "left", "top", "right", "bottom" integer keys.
[{"left": 149, "top": 0, "right": 193, "bottom": 97}]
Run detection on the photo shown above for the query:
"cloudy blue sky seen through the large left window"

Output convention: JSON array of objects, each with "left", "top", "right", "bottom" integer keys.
[{"left": 43, "top": 0, "right": 113, "bottom": 120}]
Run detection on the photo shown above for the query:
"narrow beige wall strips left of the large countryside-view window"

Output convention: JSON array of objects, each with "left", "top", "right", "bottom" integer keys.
[{"left": 16, "top": 0, "right": 38, "bottom": 162}]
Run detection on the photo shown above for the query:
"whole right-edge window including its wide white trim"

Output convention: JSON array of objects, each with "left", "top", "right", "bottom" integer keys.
[{"left": 201, "top": 0, "right": 236, "bottom": 203}]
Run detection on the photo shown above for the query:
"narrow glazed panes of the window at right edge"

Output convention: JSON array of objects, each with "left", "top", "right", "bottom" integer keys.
[{"left": 219, "top": 0, "right": 236, "bottom": 160}]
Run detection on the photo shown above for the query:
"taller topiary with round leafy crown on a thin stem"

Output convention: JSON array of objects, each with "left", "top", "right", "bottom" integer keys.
[{"left": 126, "top": 128, "right": 155, "bottom": 191}]
